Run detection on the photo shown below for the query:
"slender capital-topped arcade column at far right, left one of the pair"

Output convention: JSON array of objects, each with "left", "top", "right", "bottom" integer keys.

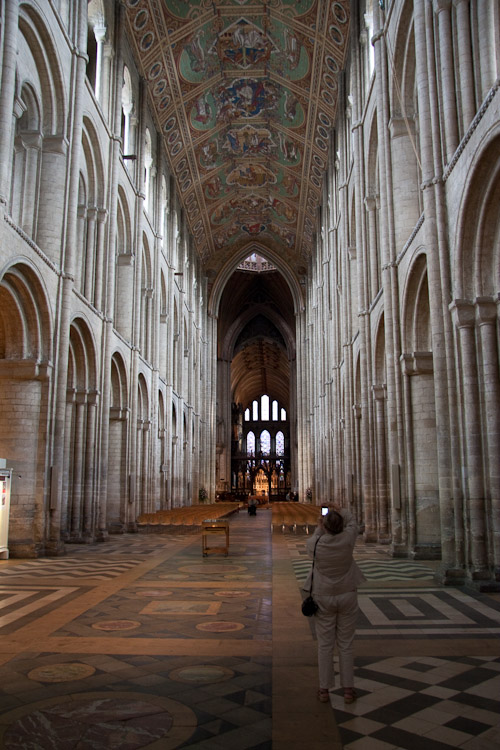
[{"left": 450, "top": 300, "right": 489, "bottom": 580}]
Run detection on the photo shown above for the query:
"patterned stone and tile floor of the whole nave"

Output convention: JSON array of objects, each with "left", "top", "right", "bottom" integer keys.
[{"left": 0, "top": 509, "right": 500, "bottom": 750}]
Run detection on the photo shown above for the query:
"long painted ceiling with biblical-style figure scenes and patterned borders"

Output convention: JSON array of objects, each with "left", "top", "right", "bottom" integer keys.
[{"left": 125, "top": 0, "right": 349, "bottom": 276}]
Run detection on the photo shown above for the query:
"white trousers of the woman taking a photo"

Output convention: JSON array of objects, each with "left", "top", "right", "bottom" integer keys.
[{"left": 314, "top": 591, "right": 359, "bottom": 689}]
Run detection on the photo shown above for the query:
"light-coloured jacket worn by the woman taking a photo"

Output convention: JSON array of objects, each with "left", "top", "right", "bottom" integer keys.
[{"left": 303, "top": 508, "right": 366, "bottom": 597}]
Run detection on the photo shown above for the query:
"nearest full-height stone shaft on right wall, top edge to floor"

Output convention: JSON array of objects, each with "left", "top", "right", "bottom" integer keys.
[{"left": 414, "top": 0, "right": 464, "bottom": 580}]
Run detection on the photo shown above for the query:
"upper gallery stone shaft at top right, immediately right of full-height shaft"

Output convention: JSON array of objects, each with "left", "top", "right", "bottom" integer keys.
[{"left": 434, "top": 0, "right": 459, "bottom": 164}]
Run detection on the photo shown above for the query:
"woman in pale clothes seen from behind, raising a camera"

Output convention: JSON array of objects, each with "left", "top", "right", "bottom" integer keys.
[{"left": 304, "top": 505, "right": 365, "bottom": 703}]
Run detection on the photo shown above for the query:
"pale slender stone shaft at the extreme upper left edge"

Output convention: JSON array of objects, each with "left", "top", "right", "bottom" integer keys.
[{"left": 0, "top": 0, "right": 20, "bottom": 206}]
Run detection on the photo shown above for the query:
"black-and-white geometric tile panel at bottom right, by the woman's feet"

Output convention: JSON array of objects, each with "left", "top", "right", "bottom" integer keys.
[{"left": 331, "top": 656, "right": 500, "bottom": 750}]
